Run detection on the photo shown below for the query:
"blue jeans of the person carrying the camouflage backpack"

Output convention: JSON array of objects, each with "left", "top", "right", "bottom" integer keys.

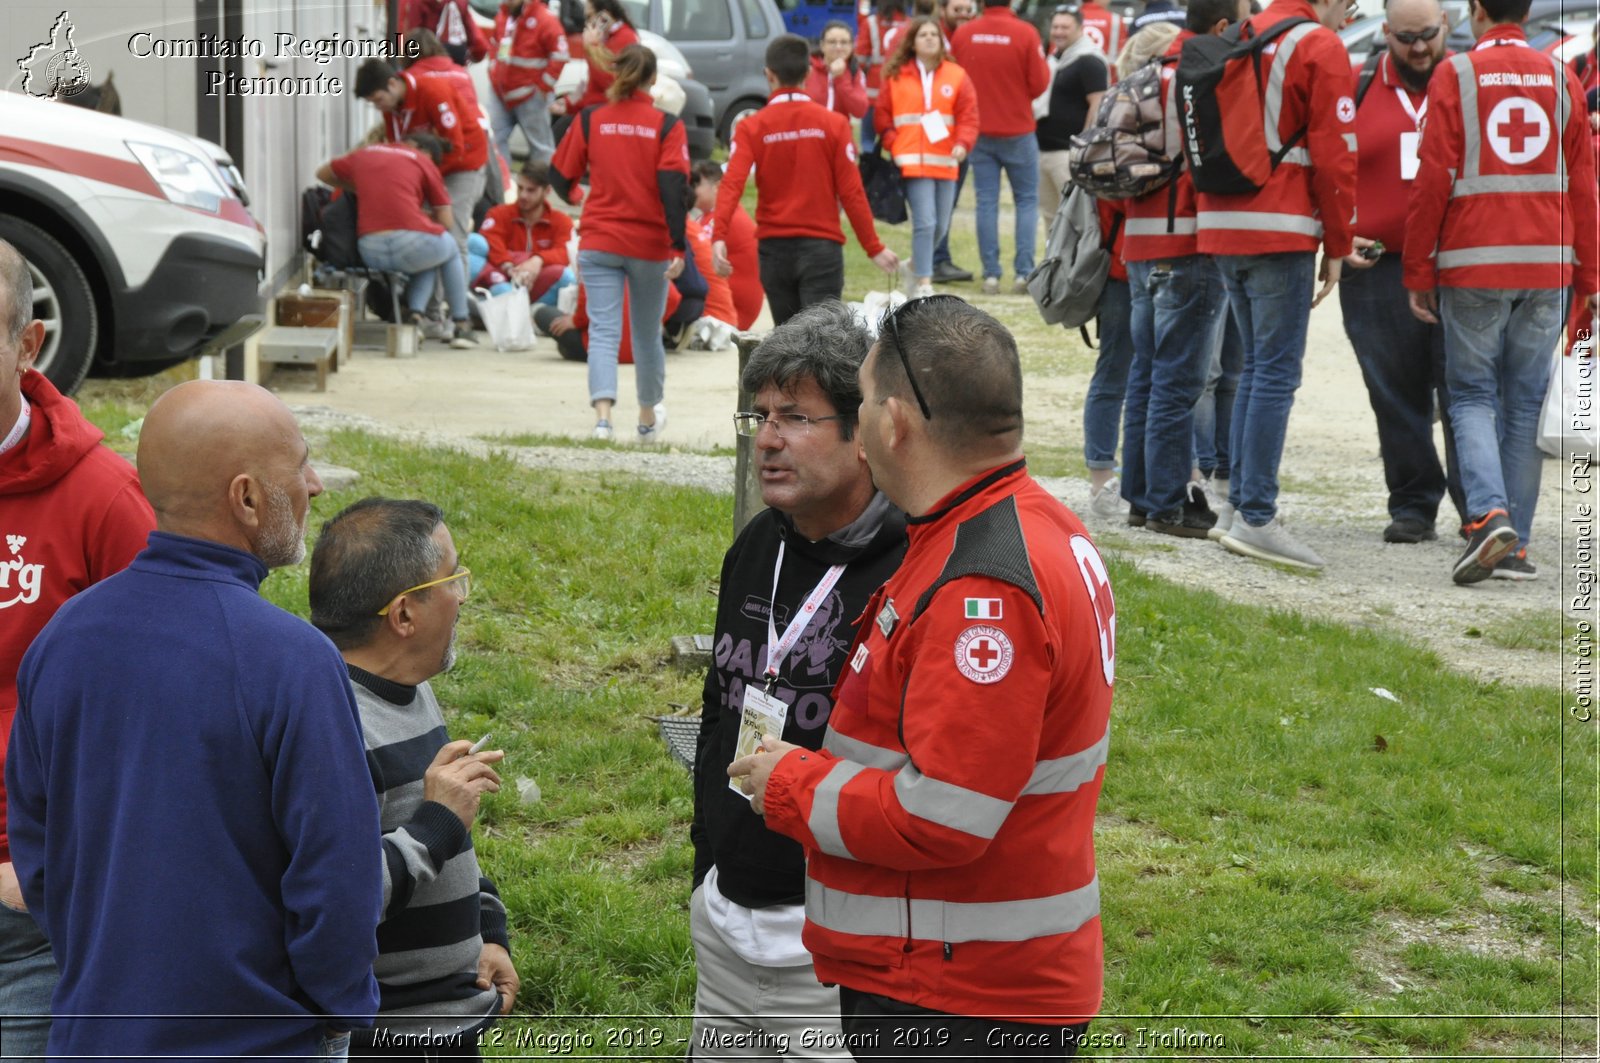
[{"left": 1122, "top": 255, "right": 1227, "bottom": 519}]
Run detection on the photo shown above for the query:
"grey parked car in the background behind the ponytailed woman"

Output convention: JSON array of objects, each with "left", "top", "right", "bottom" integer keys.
[{"left": 622, "top": 0, "right": 786, "bottom": 144}]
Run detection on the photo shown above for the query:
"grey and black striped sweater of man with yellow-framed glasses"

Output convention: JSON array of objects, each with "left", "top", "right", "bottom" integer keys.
[{"left": 347, "top": 664, "right": 510, "bottom": 1034}]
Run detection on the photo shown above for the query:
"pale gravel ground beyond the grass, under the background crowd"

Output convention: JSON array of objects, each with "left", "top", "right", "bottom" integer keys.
[{"left": 272, "top": 287, "right": 1595, "bottom": 685}]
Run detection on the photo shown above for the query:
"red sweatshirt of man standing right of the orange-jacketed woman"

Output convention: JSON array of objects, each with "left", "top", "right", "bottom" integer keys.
[{"left": 950, "top": 6, "right": 1050, "bottom": 136}]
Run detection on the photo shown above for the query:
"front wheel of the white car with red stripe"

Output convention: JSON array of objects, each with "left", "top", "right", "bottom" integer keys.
[{"left": 0, "top": 215, "right": 99, "bottom": 395}]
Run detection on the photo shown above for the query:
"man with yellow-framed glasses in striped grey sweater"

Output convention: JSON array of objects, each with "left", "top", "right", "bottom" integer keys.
[{"left": 310, "top": 498, "right": 520, "bottom": 1058}]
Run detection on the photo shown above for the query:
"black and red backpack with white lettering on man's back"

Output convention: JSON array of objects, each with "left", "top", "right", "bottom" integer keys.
[{"left": 1174, "top": 19, "right": 1317, "bottom": 195}]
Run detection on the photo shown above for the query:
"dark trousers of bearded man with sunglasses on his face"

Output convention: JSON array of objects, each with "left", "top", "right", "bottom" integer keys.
[{"left": 1339, "top": 253, "right": 1464, "bottom": 525}]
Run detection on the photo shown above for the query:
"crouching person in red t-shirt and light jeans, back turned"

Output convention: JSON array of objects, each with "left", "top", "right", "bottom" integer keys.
[{"left": 317, "top": 133, "right": 477, "bottom": 349}]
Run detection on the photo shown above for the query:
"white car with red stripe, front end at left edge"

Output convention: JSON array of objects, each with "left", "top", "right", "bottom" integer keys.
[{"left": 0, "top": 91, "right": 266, "bottom": 394}]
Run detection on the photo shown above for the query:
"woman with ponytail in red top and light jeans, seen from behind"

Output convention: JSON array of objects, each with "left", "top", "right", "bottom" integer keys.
[{"left": 550, "top": 43, "right": 690, "bottom": 443}]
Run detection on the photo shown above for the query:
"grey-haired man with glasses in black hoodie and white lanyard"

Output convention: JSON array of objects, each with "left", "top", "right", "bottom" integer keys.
[{"left": 690, "top": 301, "right": 906, "bottom": 1060}]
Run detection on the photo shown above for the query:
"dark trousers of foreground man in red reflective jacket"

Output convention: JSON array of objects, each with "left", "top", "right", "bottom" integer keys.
[{"left": 838, "top": 986, "right": 1088, "bottom": 1060}]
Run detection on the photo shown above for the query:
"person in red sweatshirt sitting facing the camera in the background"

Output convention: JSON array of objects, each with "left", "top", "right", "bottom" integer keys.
[{"left": 467, "top": 160, "right": 576, "bottom": 306}]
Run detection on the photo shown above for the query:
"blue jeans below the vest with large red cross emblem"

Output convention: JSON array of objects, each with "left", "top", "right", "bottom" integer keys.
[{"left": 1438, "top": 288, "right": 1568, "bottom": 548}]
